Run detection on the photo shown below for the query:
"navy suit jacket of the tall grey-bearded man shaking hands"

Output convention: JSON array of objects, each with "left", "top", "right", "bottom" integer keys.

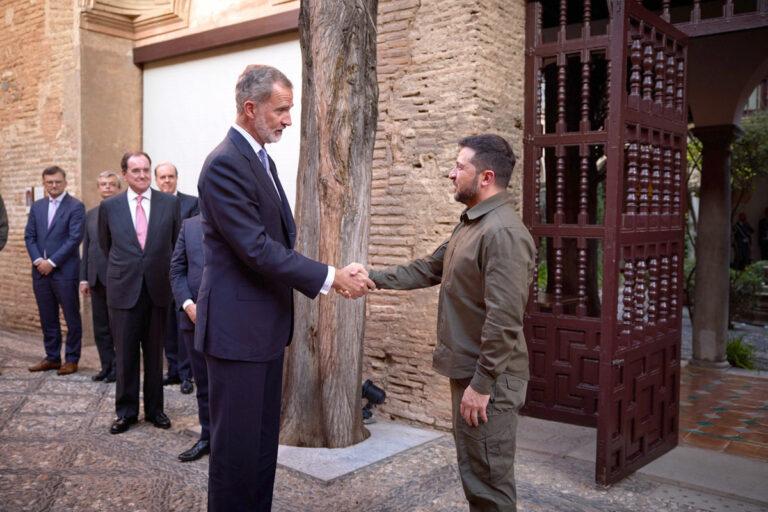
[{"left": 195, "top": 128, "right": 328, "bottom": 362}]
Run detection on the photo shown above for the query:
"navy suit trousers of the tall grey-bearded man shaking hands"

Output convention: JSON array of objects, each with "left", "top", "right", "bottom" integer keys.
[{"left": 205, "top": 354, "right": 283, "bottom": 512}]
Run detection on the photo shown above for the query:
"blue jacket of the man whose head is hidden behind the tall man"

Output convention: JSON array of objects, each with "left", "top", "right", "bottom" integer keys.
[{"left": 171, "top": 215, "right": 203, "bottom": 331}]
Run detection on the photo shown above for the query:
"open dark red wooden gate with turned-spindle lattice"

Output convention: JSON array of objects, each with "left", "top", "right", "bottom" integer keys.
[{"left": 523, "top": 0, "right": 687, "bottom": 483}]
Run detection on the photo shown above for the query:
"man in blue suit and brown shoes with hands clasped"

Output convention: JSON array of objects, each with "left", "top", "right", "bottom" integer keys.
[{"left": 24, "top": 166, "right": 85, "bottom": 375}]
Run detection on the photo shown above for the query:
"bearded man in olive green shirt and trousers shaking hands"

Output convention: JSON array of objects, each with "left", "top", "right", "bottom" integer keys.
[{"left": 369, "top": 134, "right": 536, "bottom": 512}]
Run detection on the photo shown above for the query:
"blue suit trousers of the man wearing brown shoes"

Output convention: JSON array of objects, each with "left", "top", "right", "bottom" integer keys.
[{"left": 32, "top": 276, "right": 83, "bottom": 363}]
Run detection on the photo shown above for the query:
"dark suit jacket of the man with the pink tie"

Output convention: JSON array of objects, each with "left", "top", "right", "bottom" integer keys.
[{"left": 99, "top": 189, "right": 180, "bottom": 309}]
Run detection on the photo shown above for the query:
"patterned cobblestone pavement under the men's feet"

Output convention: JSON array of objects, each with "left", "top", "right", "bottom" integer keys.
[{"left": 0, "top": 333, "right": 759, "bottom": 512}]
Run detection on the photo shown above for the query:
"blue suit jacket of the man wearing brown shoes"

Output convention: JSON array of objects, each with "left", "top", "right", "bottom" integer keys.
[{"left": 24, "top": 194, "right": 85, "bottom": 279}]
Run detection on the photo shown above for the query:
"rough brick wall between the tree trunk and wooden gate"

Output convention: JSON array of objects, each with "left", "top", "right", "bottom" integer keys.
[{"left": 364, "top": 0, "right": 525, "bottom": 427}]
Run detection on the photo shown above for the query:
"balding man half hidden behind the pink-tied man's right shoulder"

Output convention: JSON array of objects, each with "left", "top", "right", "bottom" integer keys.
[{"left": 155, "top": 162, "right": 199, "bottom": 395}]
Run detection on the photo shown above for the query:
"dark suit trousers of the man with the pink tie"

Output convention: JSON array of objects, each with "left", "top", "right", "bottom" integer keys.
[{"left": 109, "top": 283, "right": 168, "bottom": 418}]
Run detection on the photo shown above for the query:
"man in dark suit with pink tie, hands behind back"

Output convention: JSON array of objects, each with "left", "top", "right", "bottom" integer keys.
[{"left": 99, "top": 152, "right": 180, "bottom": 434}]
